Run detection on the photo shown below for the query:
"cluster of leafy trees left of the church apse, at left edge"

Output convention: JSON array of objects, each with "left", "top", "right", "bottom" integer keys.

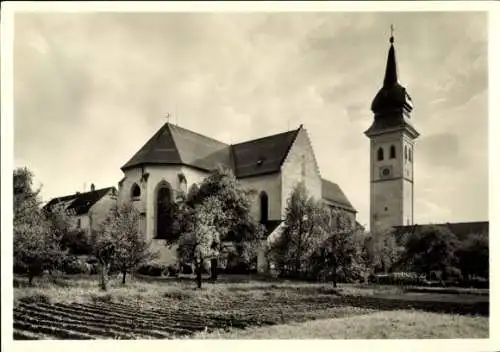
[{"left": 13, "top": 168, "right": 155, "bottom": 290}]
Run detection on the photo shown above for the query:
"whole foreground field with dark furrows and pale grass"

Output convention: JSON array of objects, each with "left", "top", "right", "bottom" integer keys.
[{"left": 14, "top": 276, "right": 489, "bottom": 339}]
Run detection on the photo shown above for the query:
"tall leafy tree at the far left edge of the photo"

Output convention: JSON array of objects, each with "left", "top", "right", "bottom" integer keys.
[{"left": 13, "top": 168, "right": 65, "bottom": 285}]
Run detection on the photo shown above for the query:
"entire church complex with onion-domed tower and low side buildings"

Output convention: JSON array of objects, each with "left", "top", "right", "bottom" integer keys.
[{"left": 45, "top": 30, "right": 489, "bottom": 272}]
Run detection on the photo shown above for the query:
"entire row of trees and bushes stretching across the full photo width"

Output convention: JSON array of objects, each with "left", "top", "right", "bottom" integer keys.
[{"left": 14, "top": 168, "right": 489, "bottom": 290}]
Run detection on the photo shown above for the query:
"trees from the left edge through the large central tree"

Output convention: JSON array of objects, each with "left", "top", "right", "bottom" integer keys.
[{"left": 14, "top": 168, "right": 264, "bottom": 290}]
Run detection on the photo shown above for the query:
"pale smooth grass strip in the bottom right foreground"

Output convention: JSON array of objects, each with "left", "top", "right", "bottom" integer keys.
[{"left": 191, "top": 311, "right": 489, "bottom": 339}]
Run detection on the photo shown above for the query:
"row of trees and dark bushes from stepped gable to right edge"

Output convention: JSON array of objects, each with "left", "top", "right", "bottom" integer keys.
[{"left": 267, "top": 184, "right": 489, "bottom": 286}]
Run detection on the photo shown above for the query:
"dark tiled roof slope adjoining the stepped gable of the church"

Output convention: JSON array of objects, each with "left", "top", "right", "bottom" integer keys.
[{"left": 231, "top": 127, "right": 301, "bottom": 178}]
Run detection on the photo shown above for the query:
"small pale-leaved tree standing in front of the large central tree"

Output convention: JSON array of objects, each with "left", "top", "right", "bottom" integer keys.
[{"left": 177, "top": 196, "right": 226, "bottom": 288}]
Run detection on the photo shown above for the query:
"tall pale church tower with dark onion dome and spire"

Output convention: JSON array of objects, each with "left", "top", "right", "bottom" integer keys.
[{"left": 365, "top": 26, "right": 419, "bottom": 231}]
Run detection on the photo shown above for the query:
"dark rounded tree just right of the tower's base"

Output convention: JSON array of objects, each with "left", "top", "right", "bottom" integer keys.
[{"left": 402, "top": 225, "right": 459, "bottom": 277}]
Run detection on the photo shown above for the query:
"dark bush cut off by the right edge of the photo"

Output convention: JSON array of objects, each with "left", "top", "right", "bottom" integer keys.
[{"left": 457, "top": 233, "right": 489, "bottom": 280}]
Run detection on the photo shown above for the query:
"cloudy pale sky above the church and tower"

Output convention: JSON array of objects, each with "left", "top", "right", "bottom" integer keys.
[{"left": 14, "top": 12, "right": 489, "bottom": 225}]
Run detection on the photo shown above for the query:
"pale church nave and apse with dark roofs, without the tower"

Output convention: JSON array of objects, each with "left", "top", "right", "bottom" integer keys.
[{"left": 118, "top": 122, "right": 356, "bottom": 263}]
